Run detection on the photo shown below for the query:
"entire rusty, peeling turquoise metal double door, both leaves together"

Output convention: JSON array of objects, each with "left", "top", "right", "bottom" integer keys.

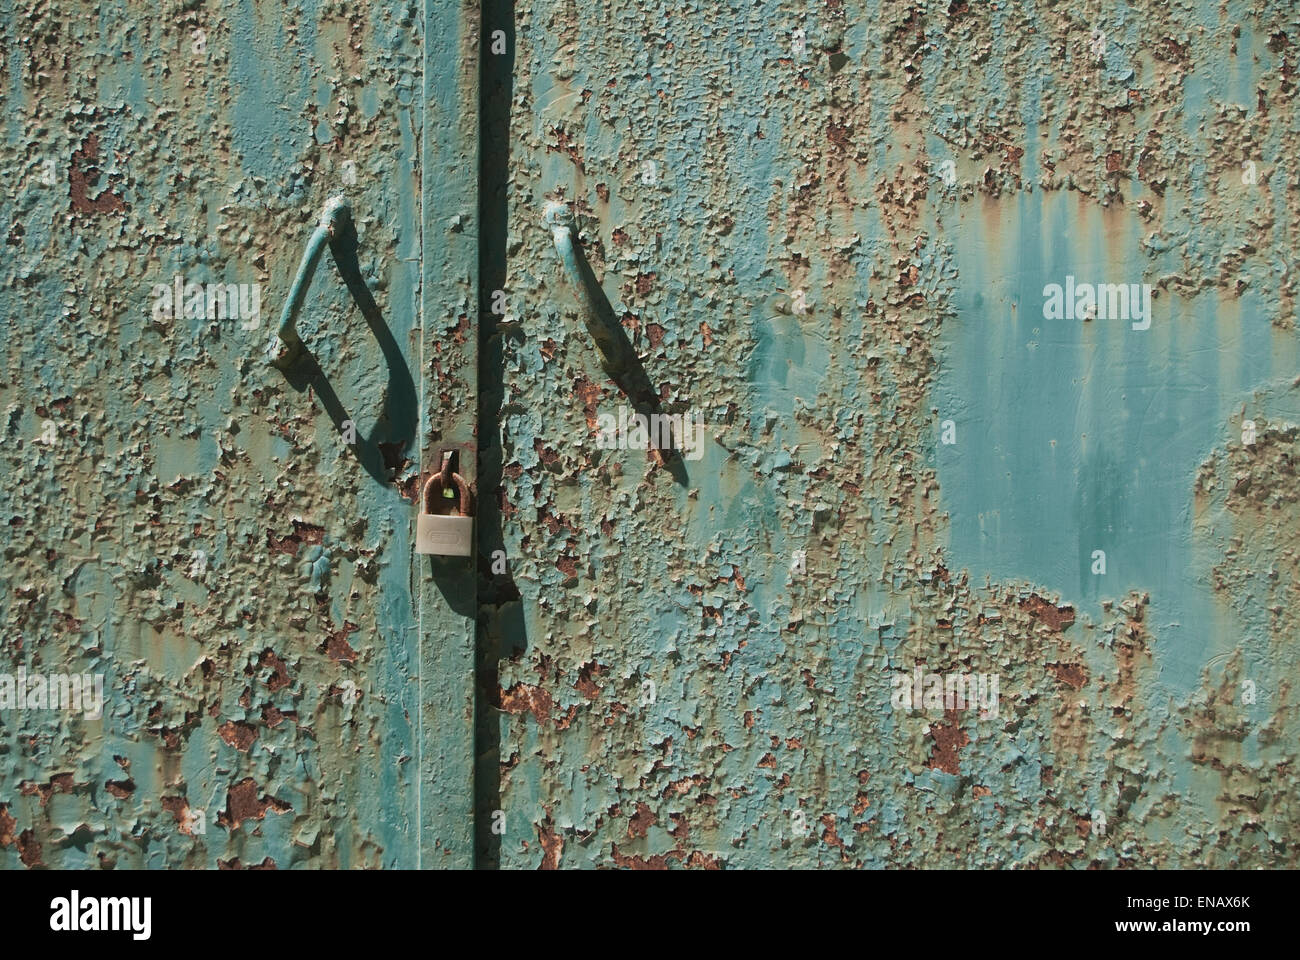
[{"left": 0, "top": 0, "right": 1300, "bottom": 869}]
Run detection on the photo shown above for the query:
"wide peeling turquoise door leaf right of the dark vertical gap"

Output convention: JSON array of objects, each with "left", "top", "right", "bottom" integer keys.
[{"left": 480, "top": 0, "right": 1300, "bottom": 868}]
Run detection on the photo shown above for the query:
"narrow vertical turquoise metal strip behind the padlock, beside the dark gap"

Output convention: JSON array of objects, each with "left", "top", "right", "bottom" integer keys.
[{"left": 411, "top": 0, "right": 480, "bottom": 868}]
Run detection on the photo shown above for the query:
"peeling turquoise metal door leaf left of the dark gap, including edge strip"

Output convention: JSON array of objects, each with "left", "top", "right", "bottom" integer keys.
[{"left": 0, "top": 0, "right": 478, "bottom": 868}]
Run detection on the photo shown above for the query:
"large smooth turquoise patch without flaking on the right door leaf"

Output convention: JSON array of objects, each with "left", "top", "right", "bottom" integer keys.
[{"left": 935, "top": 24, "right": 1295, "bottom": 695}]
